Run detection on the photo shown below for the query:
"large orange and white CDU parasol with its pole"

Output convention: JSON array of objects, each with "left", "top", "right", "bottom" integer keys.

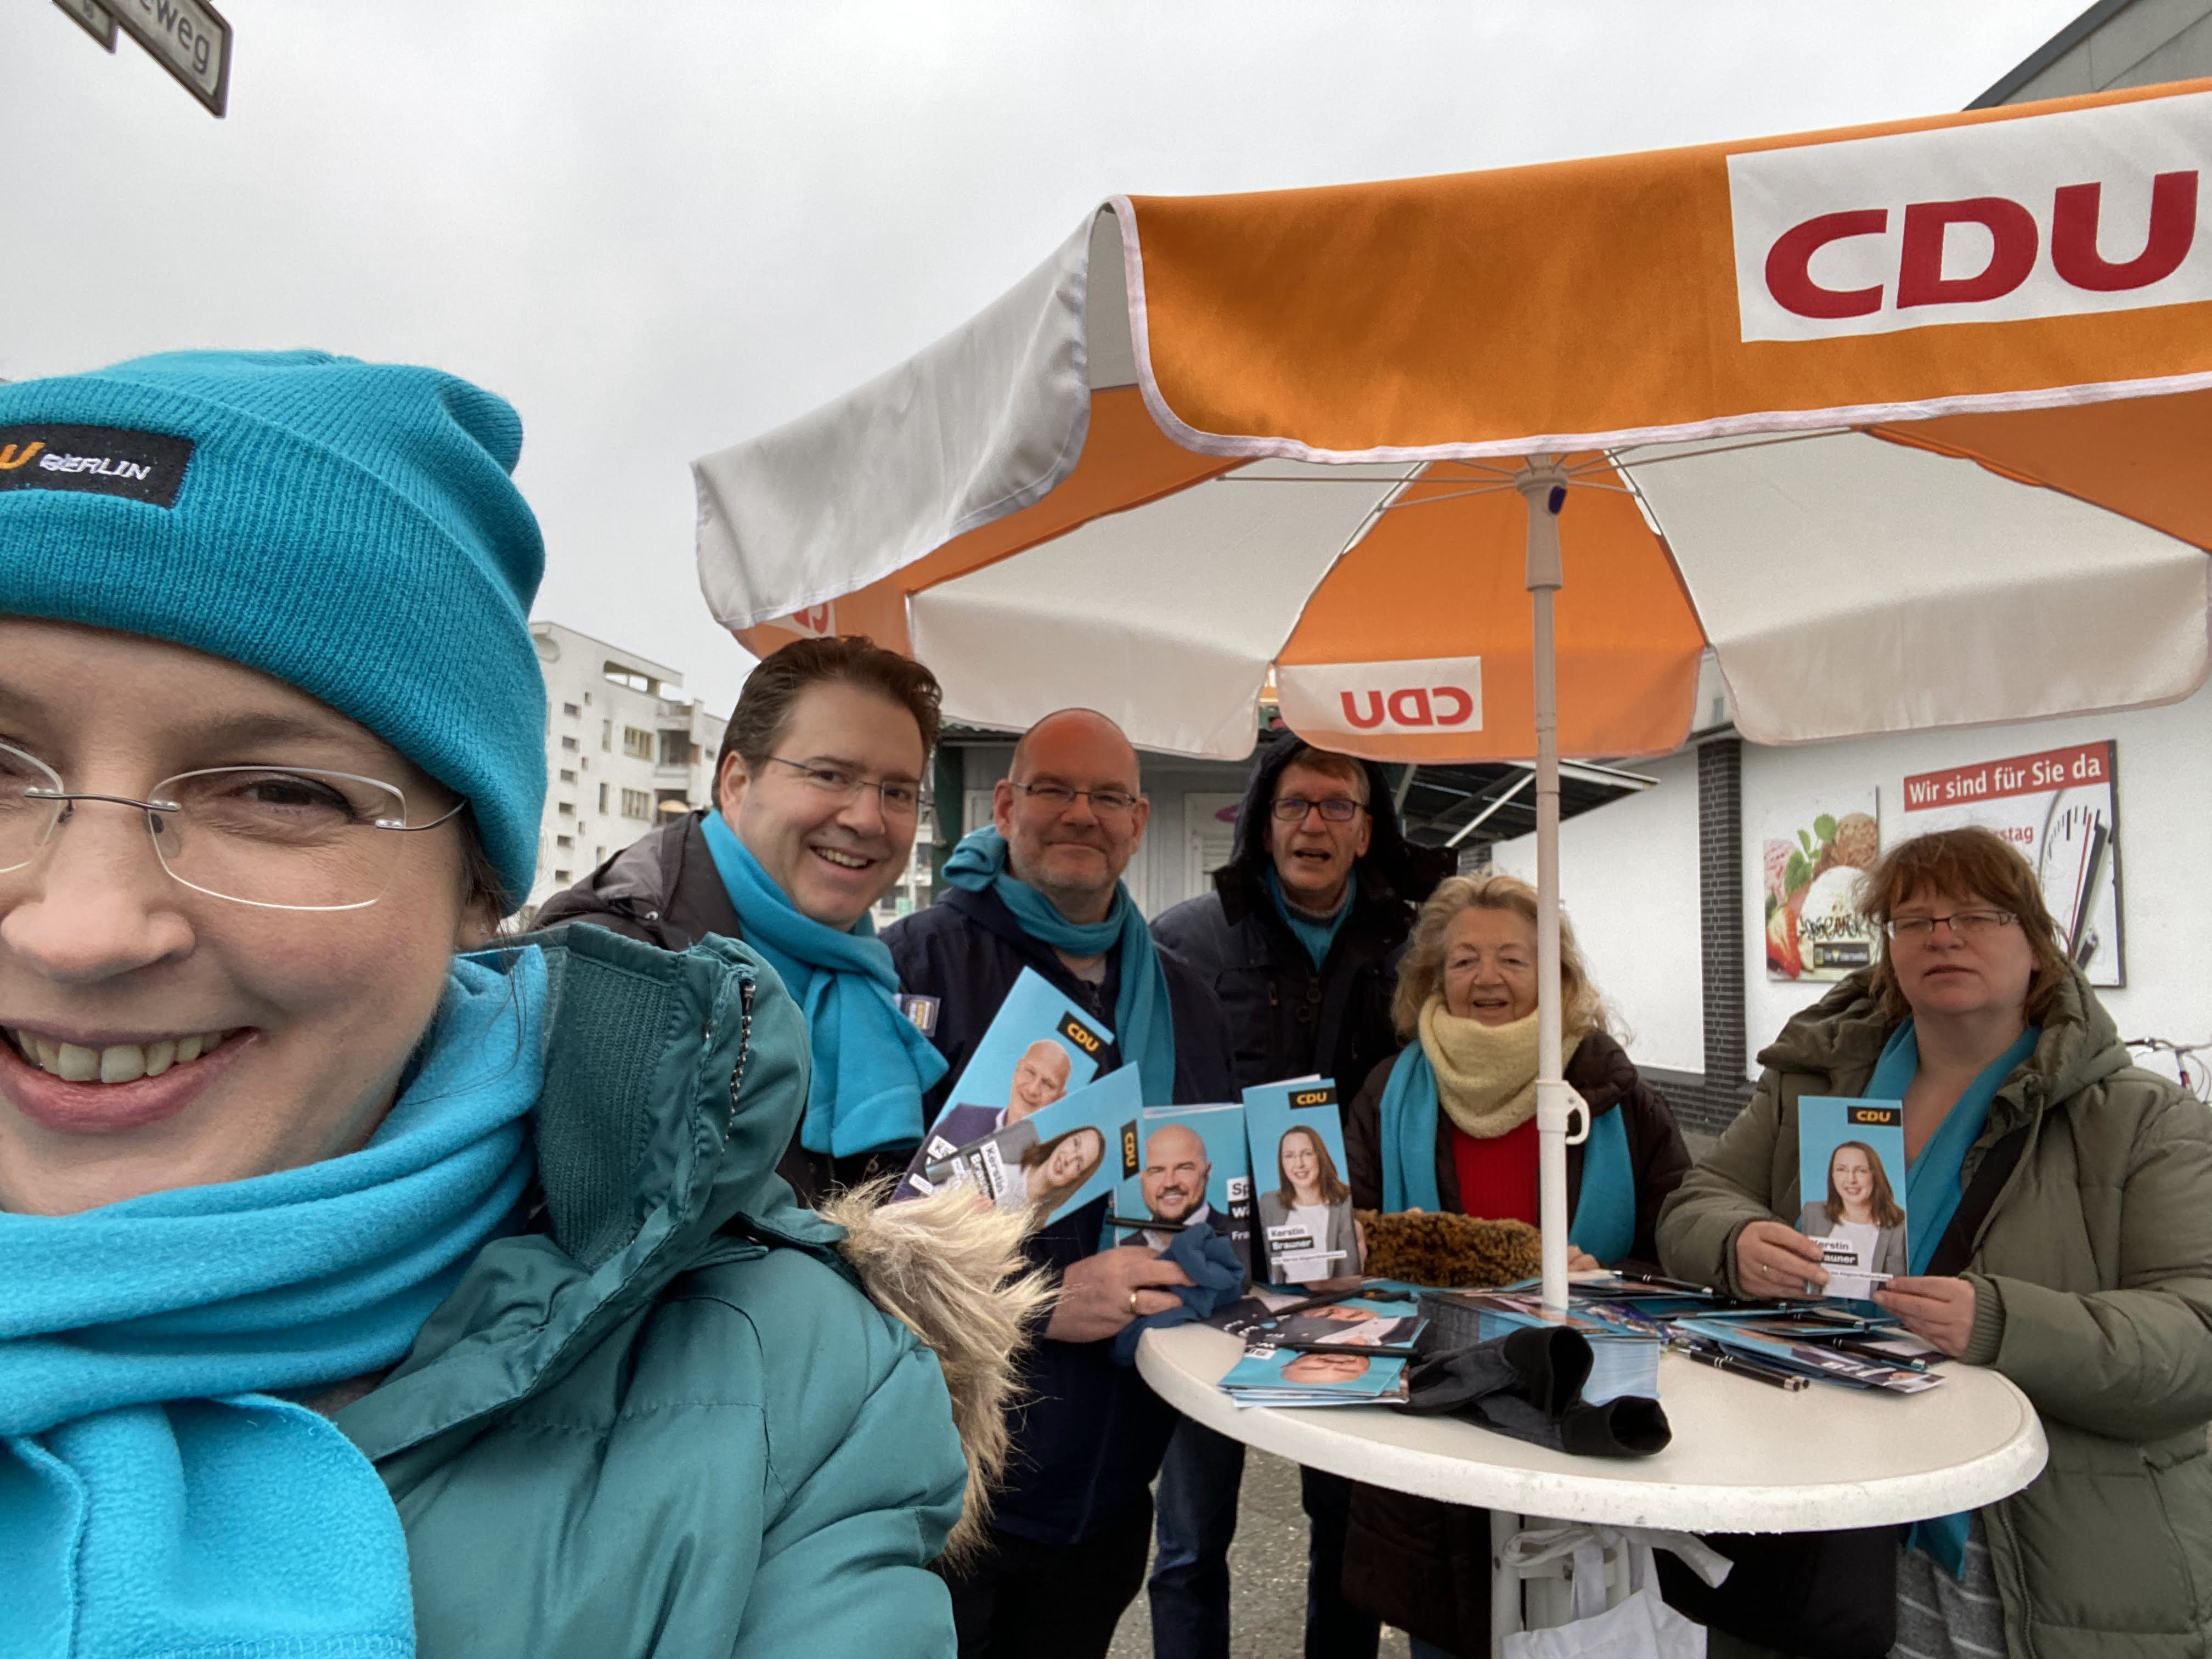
[{"left": 695, "top": 82, "right": 2212, "bottom": 1290}]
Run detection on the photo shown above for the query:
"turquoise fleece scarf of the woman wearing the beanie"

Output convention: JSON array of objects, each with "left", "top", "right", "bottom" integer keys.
[{"left": 0, "top": 949, "right": 546, "bottom": 1659}]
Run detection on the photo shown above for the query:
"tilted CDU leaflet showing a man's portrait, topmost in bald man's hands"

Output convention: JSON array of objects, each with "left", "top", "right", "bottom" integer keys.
[{"left": 891, "top": 969, "right": 1113, "bottom": 1199}]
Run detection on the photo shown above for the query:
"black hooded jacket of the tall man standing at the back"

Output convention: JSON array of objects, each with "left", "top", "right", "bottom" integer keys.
[{"left": 1153, "top": 732, "right": 1455, "bottom": 1099}]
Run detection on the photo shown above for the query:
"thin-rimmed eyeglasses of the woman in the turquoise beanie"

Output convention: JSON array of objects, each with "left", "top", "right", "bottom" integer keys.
[{"left": 0, "top": 743, "right": 467, "bottom": 909}]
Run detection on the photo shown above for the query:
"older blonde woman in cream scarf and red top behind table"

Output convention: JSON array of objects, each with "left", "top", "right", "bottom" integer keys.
[{"left": 1345, "top": 874, "right": 1690, "bottom": 1655}]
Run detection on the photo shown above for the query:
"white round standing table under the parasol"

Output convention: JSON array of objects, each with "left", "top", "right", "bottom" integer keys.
[{"left": 1137, "top": 1325, "right": 2046, "bottom": 1648}]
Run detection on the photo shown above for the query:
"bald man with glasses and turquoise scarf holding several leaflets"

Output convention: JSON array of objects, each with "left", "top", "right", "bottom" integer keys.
[{"left": 883, "top": 710, "right": 1237, "bottom": 1659}]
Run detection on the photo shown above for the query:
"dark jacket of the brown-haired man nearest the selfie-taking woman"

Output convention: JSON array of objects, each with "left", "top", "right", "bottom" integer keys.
[{"left": 533, "top": 812, "right": 913, "bottom": 1207}]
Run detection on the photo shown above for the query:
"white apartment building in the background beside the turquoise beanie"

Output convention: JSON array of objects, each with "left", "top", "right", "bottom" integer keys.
[{"left": 529, "top": 622, "right": 728, "bottom": 911}]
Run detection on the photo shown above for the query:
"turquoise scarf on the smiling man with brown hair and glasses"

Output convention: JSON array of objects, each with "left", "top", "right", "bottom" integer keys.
[{"left": 703, "top": 812, "right": 945, "bottom": 1157}]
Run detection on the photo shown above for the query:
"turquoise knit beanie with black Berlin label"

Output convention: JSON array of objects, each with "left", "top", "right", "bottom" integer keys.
[{"left": 0, "top": 352, "right": 546, "bottom": 898}]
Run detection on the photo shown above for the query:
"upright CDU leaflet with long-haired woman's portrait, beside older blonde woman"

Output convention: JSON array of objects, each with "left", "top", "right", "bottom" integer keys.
[{"left": 1245, "top": 1077, "right": 1361, "bottom": 1285}]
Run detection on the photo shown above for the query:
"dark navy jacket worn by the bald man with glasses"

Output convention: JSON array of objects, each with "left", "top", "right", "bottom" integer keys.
[{"left": 883, "top": 887, "right": 1237, "bottom": 1544}]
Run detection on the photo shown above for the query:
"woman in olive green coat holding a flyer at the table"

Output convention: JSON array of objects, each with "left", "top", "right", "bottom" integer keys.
[{"left": 1659, "top": 830, "right": 2212, "bottom": 1659}]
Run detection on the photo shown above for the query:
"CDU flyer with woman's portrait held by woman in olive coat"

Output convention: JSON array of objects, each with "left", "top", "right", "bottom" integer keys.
[{"left": 1798, "top": 1095, "right": 1909, "bottom": 1301}]
